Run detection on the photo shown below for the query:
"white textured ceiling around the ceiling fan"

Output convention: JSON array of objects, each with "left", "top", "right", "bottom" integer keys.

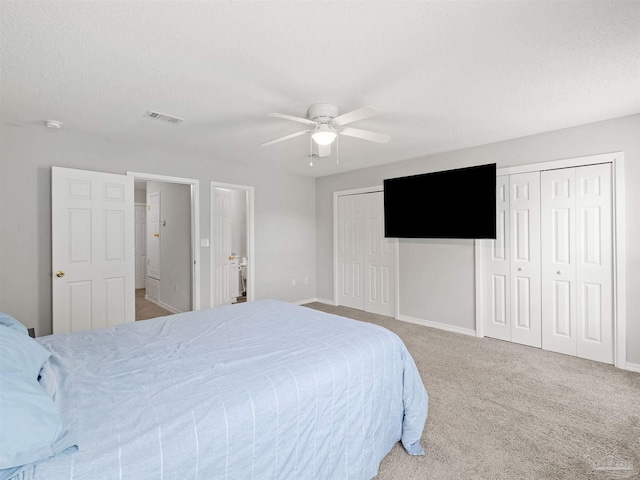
[{"left": 0, "top": 0, "right": 640, "bottom": 176}]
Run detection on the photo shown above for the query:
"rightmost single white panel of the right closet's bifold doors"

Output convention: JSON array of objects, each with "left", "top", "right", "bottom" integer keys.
[{"left": 576, "top": 164, "right": 613, "bottom": 363}]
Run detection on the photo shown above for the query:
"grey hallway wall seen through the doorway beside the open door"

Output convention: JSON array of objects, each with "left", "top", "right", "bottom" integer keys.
[{"left": 147, "top": 181, "right": 192, "bottom": 312}]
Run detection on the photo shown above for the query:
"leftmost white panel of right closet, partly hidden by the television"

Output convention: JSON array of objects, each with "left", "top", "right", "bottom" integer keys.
[{"left": 481, "top": 176, "right": 511, "bottom": 340}]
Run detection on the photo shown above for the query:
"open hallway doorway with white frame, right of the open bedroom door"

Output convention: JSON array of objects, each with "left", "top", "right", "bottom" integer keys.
[{"left": 127, "top": 172, "right": 200, "bottom": 320}]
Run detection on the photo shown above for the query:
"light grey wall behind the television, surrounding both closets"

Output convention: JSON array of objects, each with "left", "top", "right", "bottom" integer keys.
[{"left": 316, "top": 114, "right": 640, "bottom": 365}]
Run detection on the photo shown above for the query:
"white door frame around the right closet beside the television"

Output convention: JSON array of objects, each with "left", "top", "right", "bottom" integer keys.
[{"left": 475, "top": 152, "right": 627, "bottom": 369}]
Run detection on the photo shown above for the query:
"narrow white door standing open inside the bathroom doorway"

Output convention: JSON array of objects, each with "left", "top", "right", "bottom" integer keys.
[{"left": 212, "top": 188, "right": 232, "bottom": 307}]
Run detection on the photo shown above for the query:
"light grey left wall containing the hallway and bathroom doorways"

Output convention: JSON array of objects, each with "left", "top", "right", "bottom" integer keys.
[{"left": 0, "top": 122, "right": 316, "bottom": 335}]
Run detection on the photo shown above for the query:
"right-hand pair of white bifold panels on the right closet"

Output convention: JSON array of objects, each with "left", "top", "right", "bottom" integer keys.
[{"left": 541, "top": 164, "right": 613, "bottom": 363}]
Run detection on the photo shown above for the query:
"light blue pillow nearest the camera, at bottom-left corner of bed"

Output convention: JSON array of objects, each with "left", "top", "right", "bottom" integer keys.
[{"left": 0, "top": 371, "right": 78, "bottom": 474}]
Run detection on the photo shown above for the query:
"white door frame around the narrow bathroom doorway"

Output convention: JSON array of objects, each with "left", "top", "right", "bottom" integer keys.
[{"left": 209, "top": 182, "right": 256, "bottom": 308}]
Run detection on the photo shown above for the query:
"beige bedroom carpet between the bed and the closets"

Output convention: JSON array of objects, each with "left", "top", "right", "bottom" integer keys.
[{"left": 306, "top": 303, "right": 640, "bottom": 480}]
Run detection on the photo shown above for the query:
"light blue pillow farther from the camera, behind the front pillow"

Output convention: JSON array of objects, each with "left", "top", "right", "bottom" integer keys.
[{"left": 0, "top": 327, "right": 51, "bottom": 380}]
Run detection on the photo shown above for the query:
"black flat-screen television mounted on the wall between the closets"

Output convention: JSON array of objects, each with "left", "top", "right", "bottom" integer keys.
[{"left": 384, "top": 163, "right": 496, "bottom": 238}]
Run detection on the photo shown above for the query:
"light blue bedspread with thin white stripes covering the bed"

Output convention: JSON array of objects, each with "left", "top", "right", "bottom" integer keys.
[{"left": 0, "top": 300, "right": 428, "bottom": 480}]
